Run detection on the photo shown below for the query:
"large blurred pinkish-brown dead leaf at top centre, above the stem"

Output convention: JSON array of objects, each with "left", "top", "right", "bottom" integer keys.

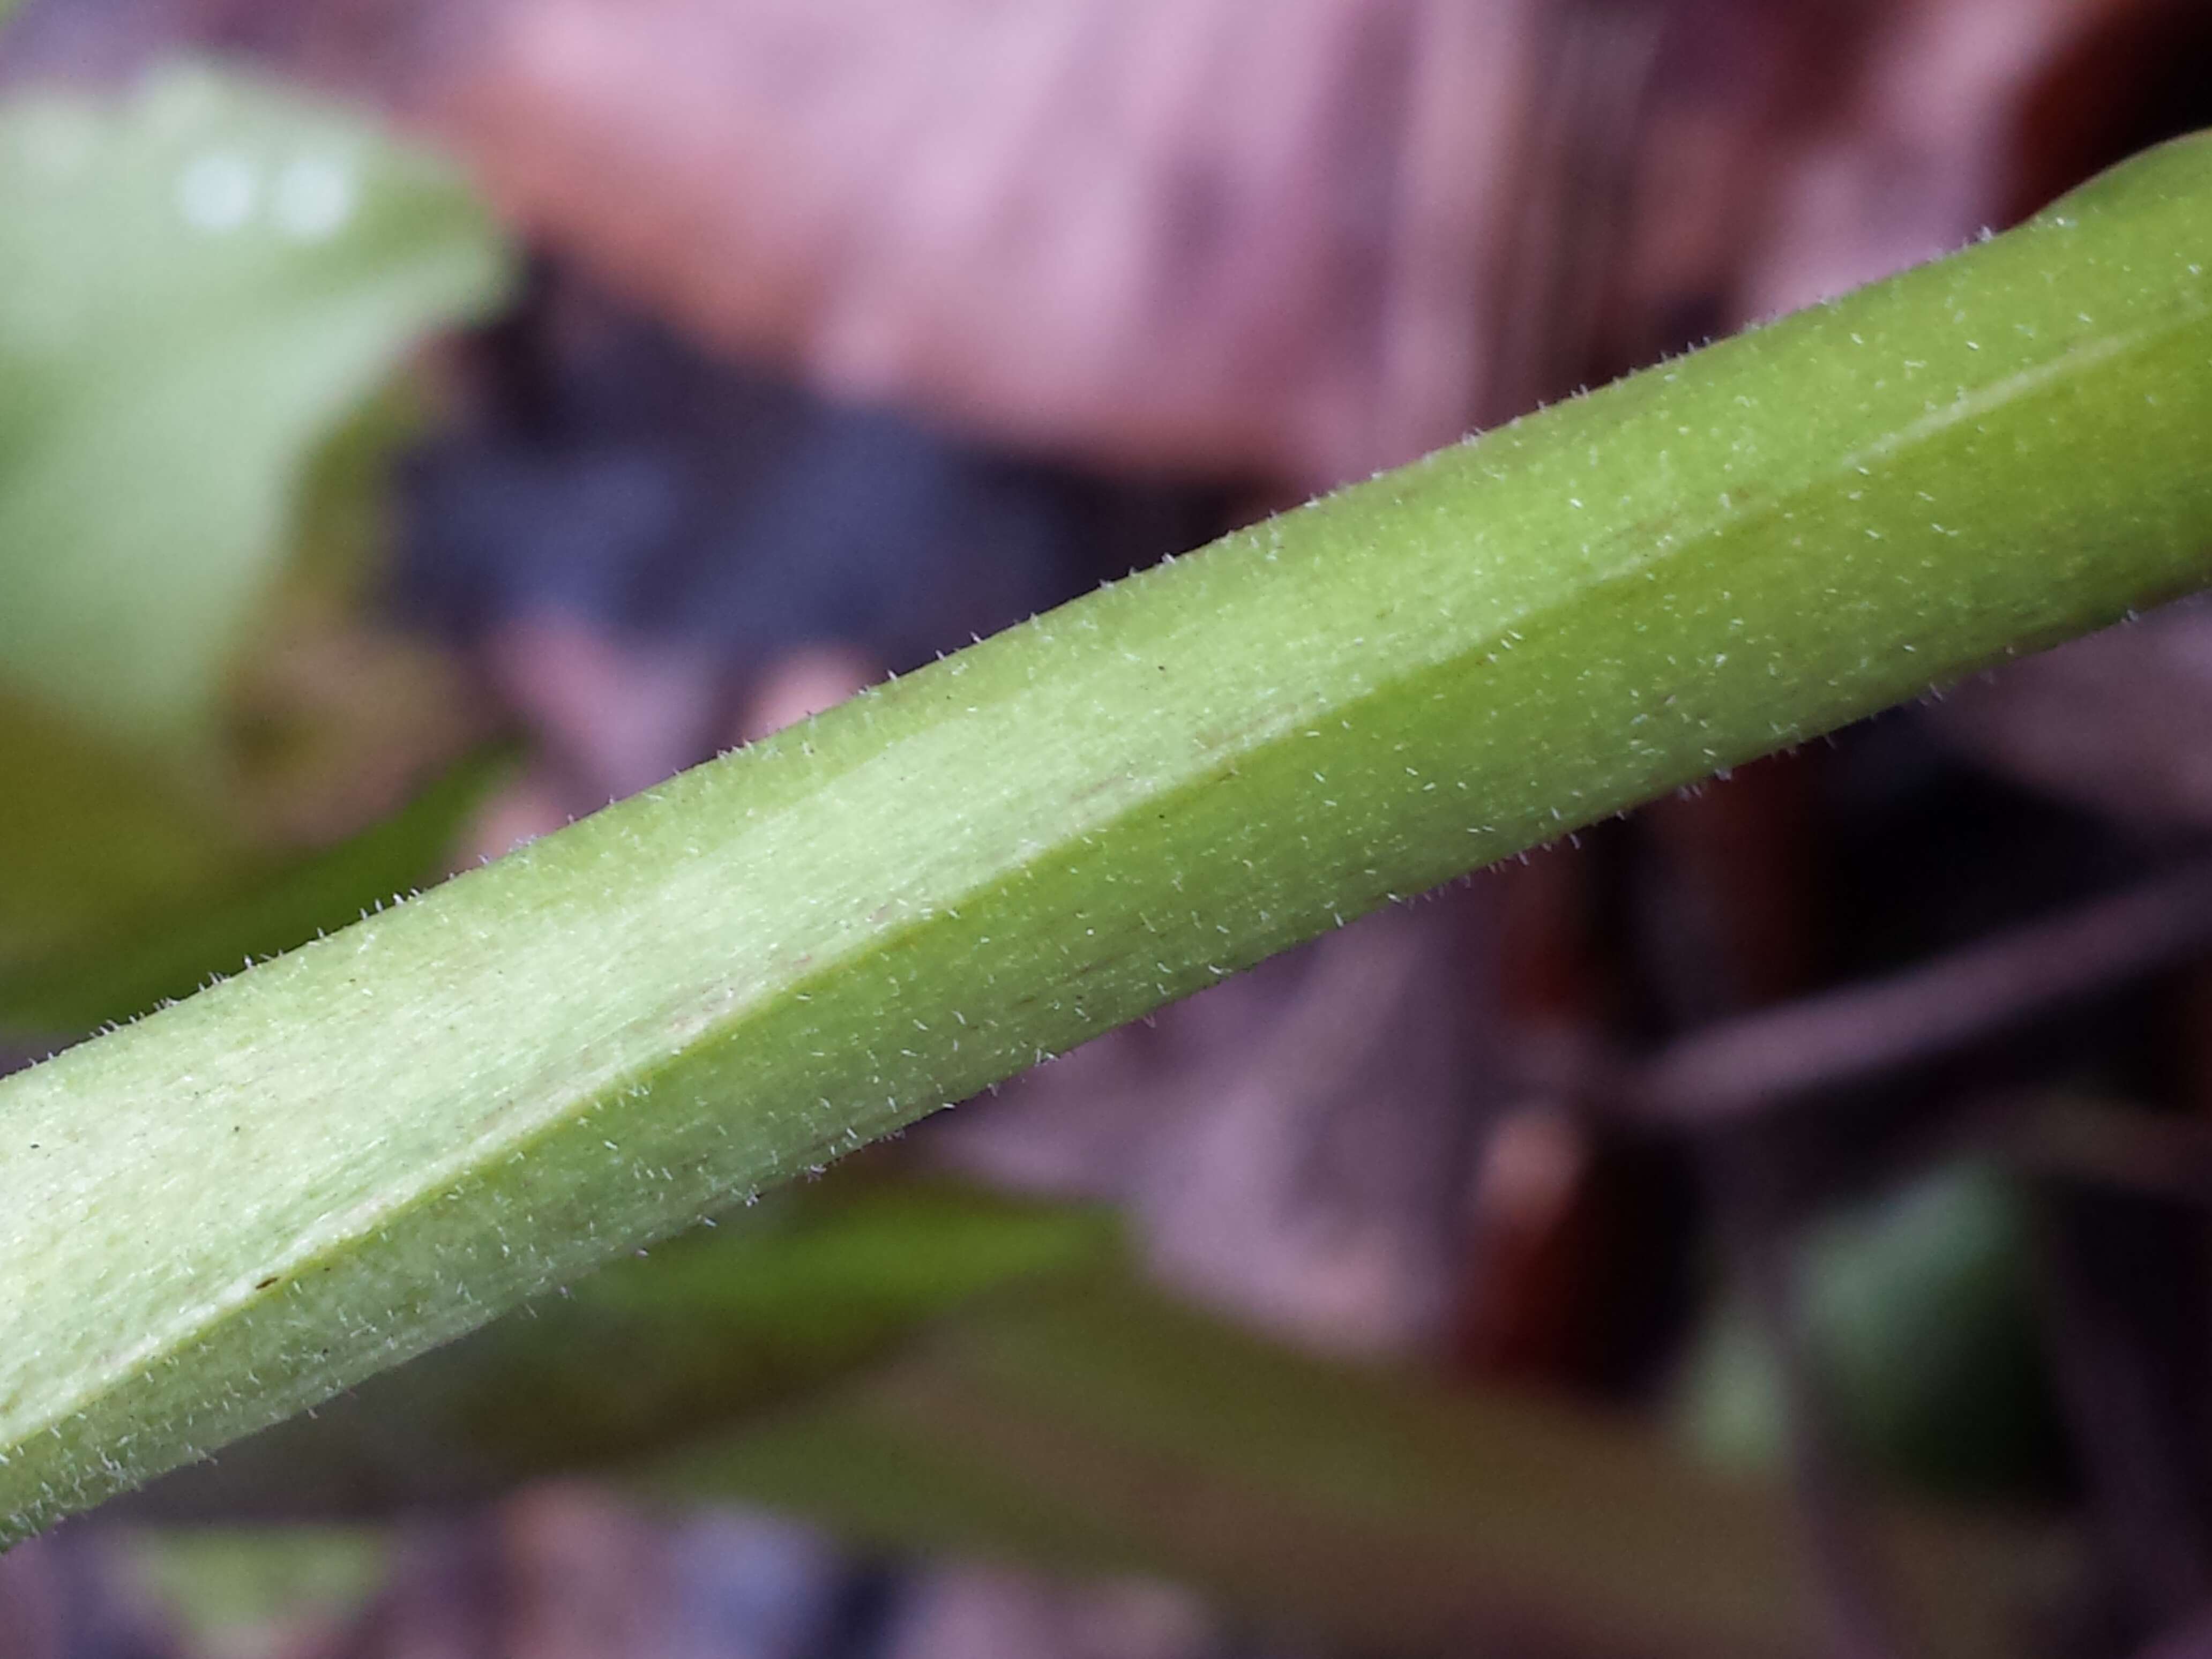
[{"left": 434, "top": 0, "right": 1535, "bottom": 480}]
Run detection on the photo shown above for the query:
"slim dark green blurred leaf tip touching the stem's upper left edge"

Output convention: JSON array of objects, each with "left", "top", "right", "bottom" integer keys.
[{"left": 0, "top": 752, "right": 509, "bottom": 1035}]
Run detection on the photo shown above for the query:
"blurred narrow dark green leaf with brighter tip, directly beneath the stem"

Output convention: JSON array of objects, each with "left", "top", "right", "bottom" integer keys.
[{"left": 131, "top": 1181, "right": 1115, "bottom": 1520}]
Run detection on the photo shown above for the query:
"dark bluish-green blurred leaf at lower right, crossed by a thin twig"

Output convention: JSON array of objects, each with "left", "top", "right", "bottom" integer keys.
[{"left": 1681, "top": 1165, "right": 2064, "bottom": 1496}]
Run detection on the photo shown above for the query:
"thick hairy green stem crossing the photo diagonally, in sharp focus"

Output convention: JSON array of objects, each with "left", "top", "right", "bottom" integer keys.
[{"left": 0, "top": 141, "right": 2212, "bottom": 1540}]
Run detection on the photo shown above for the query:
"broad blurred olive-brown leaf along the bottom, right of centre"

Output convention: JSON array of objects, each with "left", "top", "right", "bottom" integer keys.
[{"left": 657, "top": 1279, "right": 2071, "bottom": 1659}]
